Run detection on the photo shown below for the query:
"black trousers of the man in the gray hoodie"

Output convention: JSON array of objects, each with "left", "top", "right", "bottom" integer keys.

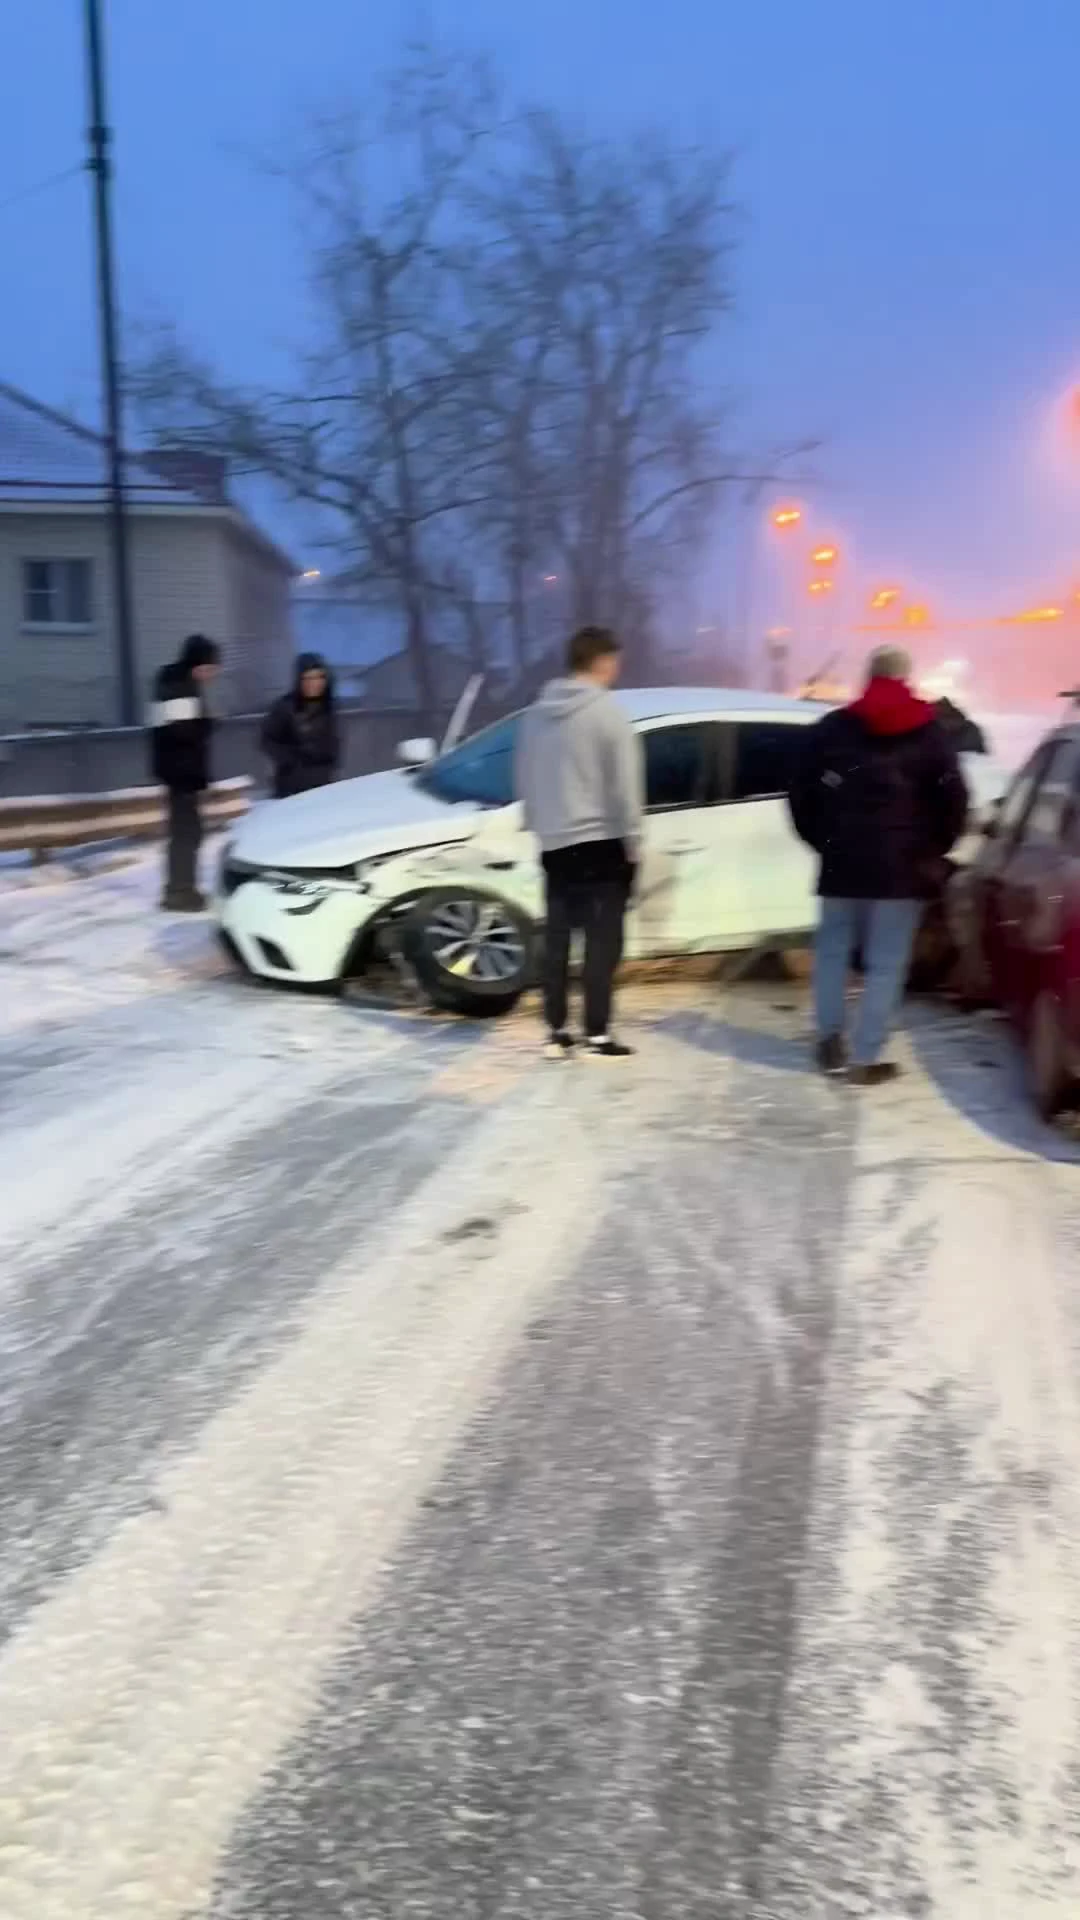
[{"left": 544, "top": 841, "right": 634, "bottom": 1039}]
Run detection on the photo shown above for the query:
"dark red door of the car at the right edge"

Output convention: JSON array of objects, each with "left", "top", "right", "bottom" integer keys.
[{"left": 994, "top": 739, "right": 1080, "bottom": 1016}]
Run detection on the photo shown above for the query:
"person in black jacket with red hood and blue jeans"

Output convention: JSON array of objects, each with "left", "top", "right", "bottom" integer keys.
[{"left": 788, "top": 647, "right": 969, "bottom": 1087}]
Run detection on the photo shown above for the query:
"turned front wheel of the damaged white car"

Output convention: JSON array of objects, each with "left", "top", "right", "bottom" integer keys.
[{"left": 398, "top": 887, "right": 536, "bottom": 1018}]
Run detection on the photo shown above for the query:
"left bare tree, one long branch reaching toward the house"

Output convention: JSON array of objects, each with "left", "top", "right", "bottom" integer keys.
[{"left": 133, "top": 50, "right": 498, "bottom": 733}]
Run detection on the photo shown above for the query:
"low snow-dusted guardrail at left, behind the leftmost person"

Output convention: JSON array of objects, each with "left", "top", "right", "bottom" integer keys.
[{"left": 0, "top": 778, "right": 254, "bottom": 858}]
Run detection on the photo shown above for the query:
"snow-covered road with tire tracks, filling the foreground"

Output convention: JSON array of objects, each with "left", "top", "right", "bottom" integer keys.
[{"left": 0, "top": 868, "right": 1080, "bottom": 1920}]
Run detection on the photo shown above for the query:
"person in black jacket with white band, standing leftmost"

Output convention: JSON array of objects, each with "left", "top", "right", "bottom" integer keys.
[{"left": 150, "top": 634, "right": 221, "bottom": 914}]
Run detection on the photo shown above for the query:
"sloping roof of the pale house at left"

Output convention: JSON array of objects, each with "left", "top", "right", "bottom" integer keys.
[{"left": 0, "top": 380, "right": 298, "bottom": 574}]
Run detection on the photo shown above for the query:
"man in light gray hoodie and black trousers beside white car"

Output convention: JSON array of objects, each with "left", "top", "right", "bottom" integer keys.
[{"left": 517, "top": 626, "right": 644, "bottom": 1060}]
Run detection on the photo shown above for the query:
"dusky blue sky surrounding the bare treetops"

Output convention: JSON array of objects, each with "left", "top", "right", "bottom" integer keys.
[{"left": 0, "top": 0, "right": 1080, "bottom": 612}]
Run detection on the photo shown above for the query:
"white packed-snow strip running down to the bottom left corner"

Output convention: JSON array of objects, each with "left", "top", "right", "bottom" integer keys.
[{"left": 0, "top": 1083, "right": 614, "bottom": 1920}]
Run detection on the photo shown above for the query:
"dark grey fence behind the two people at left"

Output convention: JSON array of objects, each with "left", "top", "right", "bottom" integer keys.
[{"left": 0, "top": 707, "right": 450, "bottom": 801}]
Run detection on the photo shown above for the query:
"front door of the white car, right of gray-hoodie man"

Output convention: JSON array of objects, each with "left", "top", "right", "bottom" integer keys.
[{"left": 626, "top": 716, "right": 721, "bottom": 956}]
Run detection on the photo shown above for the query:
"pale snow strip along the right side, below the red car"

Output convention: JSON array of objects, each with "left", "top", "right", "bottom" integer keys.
[{"left": 763, "top": 1085, "right": 1080, "bottom": 1920}]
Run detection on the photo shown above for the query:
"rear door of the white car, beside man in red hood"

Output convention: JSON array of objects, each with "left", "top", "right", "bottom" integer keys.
[{"left": 719, "top": 716, "right": 817, "bottom": 943}]
